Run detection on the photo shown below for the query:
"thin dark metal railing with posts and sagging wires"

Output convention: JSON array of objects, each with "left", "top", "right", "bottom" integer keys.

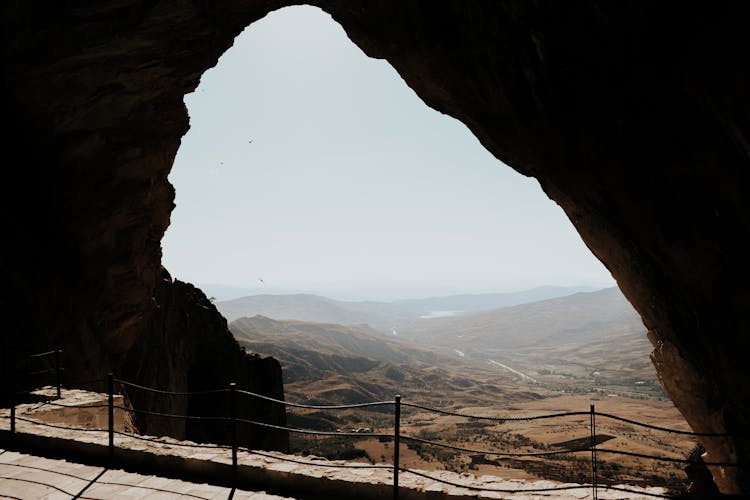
[{"left": 4, "top": 349, "right": 739, "bottom": 499}]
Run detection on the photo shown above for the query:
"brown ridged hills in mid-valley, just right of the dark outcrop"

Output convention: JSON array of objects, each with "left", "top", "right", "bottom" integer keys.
[{"left": 229, "top": 316, "right": 536, "bottom": 404}]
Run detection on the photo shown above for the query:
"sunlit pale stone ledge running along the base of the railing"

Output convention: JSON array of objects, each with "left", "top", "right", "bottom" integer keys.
[{"left": 0, "top": 426, "right": 664, "bottom": 500}]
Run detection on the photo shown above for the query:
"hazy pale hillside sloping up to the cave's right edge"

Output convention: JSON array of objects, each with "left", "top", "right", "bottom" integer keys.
[{"left": 401, "top": 287, "right": 664, "bottom": 397}]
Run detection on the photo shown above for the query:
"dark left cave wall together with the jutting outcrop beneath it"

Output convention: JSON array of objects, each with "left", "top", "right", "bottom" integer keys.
[{"left": 0, "top": 2, "right": 288, "bottom": 450}]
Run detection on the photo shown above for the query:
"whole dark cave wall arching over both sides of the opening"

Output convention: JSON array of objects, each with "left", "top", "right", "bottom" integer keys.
[{"left": 0, "top": 0, "right": 750, "bottom": 493}]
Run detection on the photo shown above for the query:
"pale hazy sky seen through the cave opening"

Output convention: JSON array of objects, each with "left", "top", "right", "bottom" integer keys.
[{"left": 163, "top": 7, "right": 614, "bottom": 299}]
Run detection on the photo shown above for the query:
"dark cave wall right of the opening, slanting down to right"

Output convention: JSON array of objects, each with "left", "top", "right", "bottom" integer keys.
[{"left": 312, "top": 1, "right": 750, "bottom": 493}]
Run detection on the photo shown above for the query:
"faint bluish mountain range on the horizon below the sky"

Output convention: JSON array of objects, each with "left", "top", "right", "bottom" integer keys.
[{"left": 216, "top": 286, "right": 592, "bottom": 334}]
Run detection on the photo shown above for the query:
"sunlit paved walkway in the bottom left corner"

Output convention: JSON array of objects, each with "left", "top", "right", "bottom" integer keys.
[{"left": 0, "top": 450, "right": 289, "bottom": 500}]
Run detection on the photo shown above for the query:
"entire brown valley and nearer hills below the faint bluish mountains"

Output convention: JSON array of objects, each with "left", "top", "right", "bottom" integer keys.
[{"left": 230, "top": 288, "right": 696, "bottom": 491}]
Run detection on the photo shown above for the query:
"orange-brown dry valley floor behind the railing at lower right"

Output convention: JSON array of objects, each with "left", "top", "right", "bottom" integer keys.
[{"left": 355, "top": 394, "right": 696, "bottom": 489}]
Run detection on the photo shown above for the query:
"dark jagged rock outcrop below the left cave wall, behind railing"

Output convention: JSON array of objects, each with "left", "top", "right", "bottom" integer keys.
[{"left": 121, "top": 271, "right": 289, "bottom": 451}]
